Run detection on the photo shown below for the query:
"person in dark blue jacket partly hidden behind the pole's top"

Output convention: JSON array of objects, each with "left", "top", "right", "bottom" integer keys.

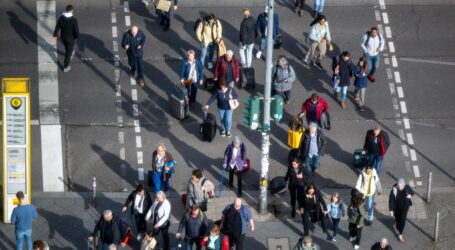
[{"left": 256, "top": 6, "right": 280, "bottom": 59}]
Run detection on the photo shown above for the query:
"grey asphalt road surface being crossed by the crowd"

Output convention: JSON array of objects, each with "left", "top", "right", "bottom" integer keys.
[{"left": 0, "top": 1, "right": 455, "bottom": 195}]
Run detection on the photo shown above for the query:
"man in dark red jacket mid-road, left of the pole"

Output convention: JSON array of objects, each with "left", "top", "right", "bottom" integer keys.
[{"left": 213, "top": 50, "right": 240, "bottom": 88}]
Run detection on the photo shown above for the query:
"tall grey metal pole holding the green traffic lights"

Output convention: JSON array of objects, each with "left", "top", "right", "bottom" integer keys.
[{"left": 258, "top": 0, "right": 274, "bottom": 214}]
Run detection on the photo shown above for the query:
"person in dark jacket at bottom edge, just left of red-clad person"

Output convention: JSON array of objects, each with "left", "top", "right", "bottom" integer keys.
[{"left": 175, "top": 204, "right": 208, "bottom": 250}]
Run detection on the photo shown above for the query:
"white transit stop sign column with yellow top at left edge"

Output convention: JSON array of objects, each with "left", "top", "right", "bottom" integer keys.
[{"left": 2, "top": 78, "right": 31, "bottom": 223}]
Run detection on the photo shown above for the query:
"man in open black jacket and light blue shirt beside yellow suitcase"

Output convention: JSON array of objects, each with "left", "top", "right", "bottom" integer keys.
[{"left": 300, "top": 122, "right": 327, "bottom": 175}]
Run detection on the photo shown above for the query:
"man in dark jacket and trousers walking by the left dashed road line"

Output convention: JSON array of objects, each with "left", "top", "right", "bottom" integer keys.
[{"left": 122, "top": 26, "right": 145, "bottom": 87}]
